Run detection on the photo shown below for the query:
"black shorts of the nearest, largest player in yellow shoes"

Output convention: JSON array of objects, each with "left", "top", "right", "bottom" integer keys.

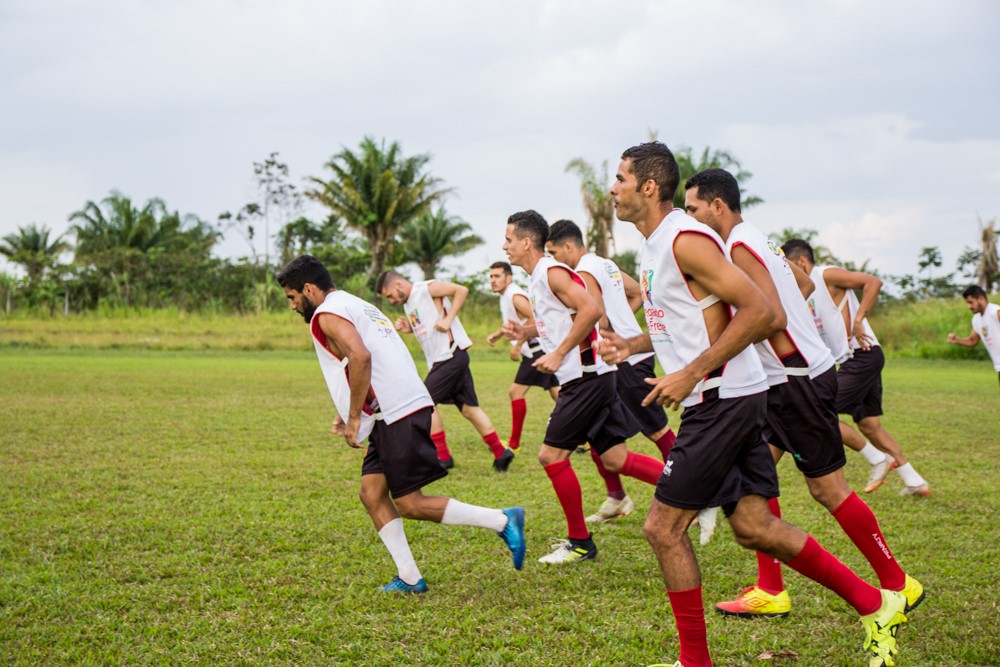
[{"left": 656, "top": 389, "right": 778, "bottom": 516}]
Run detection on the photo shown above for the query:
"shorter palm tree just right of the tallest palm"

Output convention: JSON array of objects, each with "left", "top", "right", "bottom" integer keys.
[{"left": 399, "top": 206, "right": 483, "bottom": 280}]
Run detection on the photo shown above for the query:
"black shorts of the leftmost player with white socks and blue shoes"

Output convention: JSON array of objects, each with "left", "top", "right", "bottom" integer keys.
[{"left": 361, "top": 408, "right": 448, "bottom": 498}]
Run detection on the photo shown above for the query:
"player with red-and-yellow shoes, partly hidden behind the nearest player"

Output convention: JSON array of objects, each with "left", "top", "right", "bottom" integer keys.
[{"left": 684, "top": 169, "right": 924, "bottom": 617}]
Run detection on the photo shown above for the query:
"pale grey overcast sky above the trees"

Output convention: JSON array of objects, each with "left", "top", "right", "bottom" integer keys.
[{"left": 0, "top": 0, "right": 1000, "bottom": 284}]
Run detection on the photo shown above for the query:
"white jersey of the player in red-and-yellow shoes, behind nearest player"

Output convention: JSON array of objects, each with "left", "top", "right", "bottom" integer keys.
[{"left": 726, "top": 221, "right": 833, "bottom": 387}]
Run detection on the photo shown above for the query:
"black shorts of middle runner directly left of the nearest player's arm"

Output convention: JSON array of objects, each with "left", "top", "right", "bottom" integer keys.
[{"left": 544, "top": 372, "right": 639, "bottom": 454}]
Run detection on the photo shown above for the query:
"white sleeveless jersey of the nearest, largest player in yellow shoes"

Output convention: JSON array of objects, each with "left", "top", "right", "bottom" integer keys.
[{"left": 639, "top": 209, "right": 767, "bottom": 406}]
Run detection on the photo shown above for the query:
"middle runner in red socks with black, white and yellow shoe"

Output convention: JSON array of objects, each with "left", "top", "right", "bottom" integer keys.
[{"left": 503, "top": 210, "right": 663, "bottom": 565}]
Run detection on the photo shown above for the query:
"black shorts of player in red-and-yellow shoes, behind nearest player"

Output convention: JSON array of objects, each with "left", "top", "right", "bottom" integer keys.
[{"left": 764, "top": 368, "right": 847, "bottom": 477}]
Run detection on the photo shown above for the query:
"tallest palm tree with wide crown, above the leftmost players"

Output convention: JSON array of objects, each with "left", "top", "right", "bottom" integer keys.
[{"left": 306, "top": 137, "right": 450, "bottom": 282}]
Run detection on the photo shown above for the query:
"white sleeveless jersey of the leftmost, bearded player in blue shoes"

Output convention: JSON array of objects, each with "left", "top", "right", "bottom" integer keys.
[{"left": 309, "top": 291, "right": 434, "bottom": 442}]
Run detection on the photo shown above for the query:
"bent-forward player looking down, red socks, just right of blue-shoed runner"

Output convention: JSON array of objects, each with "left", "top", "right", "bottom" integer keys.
[{"left": 375, "top": 271, "right": 514, "bottom": 472}]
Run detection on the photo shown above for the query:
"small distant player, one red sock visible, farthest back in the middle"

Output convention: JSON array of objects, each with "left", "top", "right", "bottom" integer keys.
[{"left": 486, "top": 262, "right": 559, "bottom": 452}]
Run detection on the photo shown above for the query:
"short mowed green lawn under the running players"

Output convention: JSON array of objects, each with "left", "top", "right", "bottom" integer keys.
[{"left": 0, "top": 350, "right": 1000, "bottom": 667}]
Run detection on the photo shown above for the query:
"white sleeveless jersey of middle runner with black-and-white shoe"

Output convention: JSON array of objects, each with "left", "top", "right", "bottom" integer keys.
[{"left": 528, "top": 256, "right": 618, "bottom": 385}]
